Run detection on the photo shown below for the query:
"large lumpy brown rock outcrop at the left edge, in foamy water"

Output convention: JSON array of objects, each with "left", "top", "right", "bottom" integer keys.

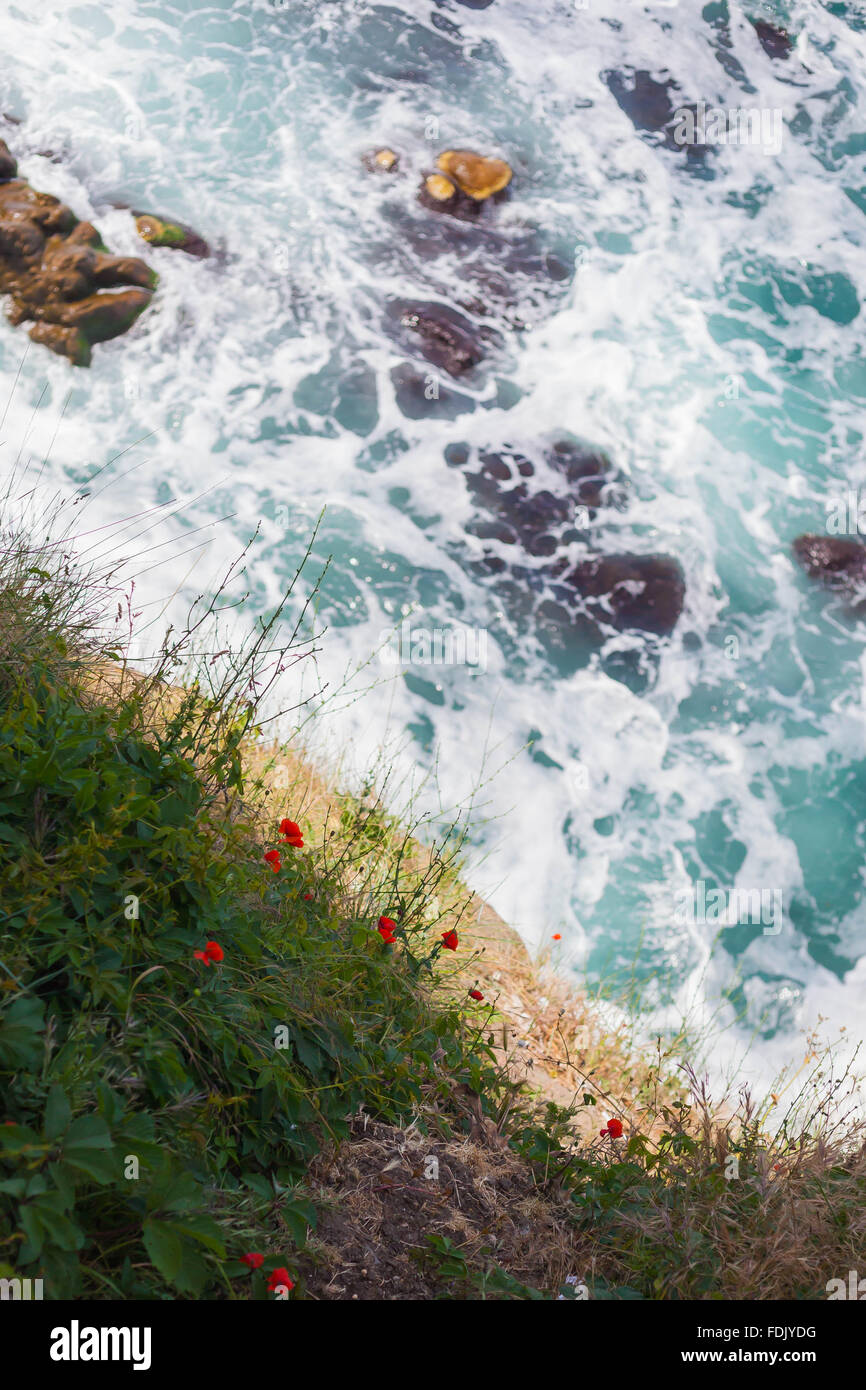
[{"left": 0, "top": 162, "right": 157, "bottom": 367}]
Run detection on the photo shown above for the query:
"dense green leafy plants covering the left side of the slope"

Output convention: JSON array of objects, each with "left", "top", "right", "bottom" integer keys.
[{"left": 0, "top": 505, "right": 508, "bottom": 1298}]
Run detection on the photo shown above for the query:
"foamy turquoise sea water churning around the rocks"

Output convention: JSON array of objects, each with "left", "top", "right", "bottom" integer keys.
[{"left": 0, "top": 0, "right": 866, "bottom": 1074}]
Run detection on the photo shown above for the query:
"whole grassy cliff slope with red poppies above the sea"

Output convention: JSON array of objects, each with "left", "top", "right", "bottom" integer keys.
[{"left": 0, "top": 522, "right": 866, "bottom": 1300}]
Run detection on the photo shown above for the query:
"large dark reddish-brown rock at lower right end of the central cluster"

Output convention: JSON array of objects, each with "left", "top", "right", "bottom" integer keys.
[{"left": 563, "top": 555, "right": 685, "bottom": 637}]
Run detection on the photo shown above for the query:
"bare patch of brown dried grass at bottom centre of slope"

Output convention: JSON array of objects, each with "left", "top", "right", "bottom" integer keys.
[{"left": 291, "top": 1116, "right": 577, "bottom": 1301}]
